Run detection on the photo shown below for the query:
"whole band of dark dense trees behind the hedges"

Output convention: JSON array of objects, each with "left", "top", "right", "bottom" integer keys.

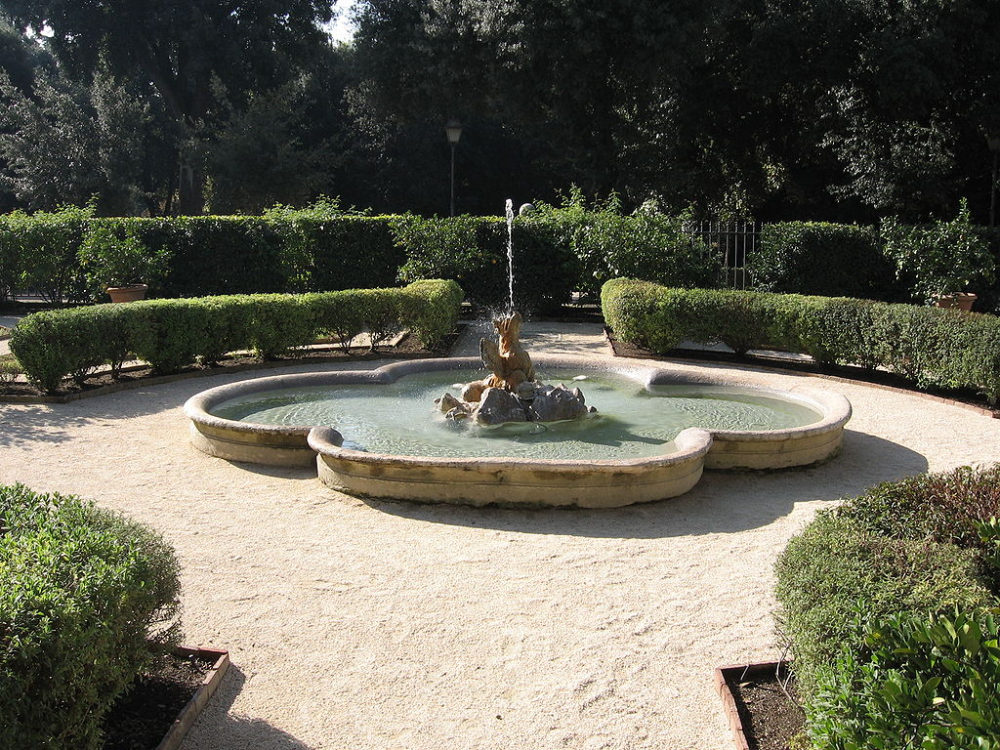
[{"left": 0, "top": 0, "right": 1000, "bottom": 221}]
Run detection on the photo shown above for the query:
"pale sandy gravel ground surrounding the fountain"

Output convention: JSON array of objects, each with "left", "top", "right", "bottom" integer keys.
[{"left": 0, "top": 328, "right": 1000, "bottom": 750}]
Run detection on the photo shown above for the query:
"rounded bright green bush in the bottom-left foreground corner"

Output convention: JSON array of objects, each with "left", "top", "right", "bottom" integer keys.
[{"left": 0, "top": 485, "right": 180, "bottom": 750}]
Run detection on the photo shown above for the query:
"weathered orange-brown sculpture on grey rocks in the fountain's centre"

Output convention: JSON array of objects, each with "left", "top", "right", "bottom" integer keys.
[{"left": 434, "top": 312, "right": 597, "bottom": 425}]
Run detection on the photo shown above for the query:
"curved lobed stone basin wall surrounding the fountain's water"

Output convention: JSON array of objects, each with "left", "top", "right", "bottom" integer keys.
[{"left": 185, "top": 356, "right": 851, "bottom": 507}]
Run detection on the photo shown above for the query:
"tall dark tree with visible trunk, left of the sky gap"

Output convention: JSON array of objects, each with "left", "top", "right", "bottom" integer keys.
[{"left": 6, "top": 0, "right": 332, "bottom": 213}]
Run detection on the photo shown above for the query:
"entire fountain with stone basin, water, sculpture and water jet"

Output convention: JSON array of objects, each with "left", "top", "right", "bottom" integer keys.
[{"left": 185, "top": 201, "right": 851, "bottom": 507}]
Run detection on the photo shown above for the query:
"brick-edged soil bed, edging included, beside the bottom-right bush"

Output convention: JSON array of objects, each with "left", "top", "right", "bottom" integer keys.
[{"left": 716, "top": 662, "right": 805, "bottom": 750}]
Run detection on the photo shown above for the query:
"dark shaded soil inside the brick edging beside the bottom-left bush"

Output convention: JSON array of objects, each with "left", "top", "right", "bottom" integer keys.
[{"left": 103, "top": 655, "right": 212, "bottom": 750}]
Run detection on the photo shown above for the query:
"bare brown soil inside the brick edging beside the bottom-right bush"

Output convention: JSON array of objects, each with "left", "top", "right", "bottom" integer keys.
[{"left": 730, "top": 669, "right": 805, "bottom": 750}]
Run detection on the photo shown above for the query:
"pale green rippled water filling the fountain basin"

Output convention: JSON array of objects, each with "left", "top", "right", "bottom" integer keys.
[{"left": 212, "top": 370, "right": 820, "bottom": 460}]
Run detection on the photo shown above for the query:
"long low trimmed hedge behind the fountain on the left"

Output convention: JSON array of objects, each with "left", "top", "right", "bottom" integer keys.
[{"left": 10, "top": 280, "right": 463, "bottom": 392}]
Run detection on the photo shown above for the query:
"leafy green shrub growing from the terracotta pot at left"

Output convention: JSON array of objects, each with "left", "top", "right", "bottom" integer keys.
[{"left": 78, "top": 224, "right": 170, "bottom": 299}]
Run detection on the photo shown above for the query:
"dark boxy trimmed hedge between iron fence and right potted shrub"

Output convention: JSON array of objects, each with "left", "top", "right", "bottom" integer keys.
[{"left": 746, "top": 222, "right": 896, "bottom": 300}]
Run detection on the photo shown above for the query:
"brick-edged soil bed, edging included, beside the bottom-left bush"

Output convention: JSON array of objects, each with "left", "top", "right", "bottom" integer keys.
[{"left": 103, "top": 648, "right": 228, "bottom": 750}]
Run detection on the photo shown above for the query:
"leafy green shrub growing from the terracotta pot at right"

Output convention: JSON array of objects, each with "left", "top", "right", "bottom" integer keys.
[{"left": 881, "top": 200, "right": 996, "bottom": 303}]
